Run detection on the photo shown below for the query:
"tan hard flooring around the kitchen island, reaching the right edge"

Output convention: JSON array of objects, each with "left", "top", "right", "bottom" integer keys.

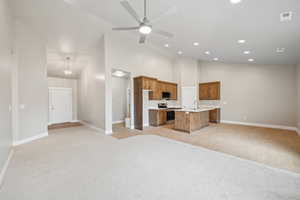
[{"left": 113, "top": 124, "right": 300, "bottom": 173}]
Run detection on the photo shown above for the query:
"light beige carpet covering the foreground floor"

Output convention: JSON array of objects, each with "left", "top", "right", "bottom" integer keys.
[{"left": 0, "top": 127, "right": 300, "bottom": 200}]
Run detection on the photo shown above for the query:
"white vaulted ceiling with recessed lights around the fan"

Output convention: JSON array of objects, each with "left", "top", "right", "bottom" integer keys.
[{"left": 12, "top": 0, "right": 300, "bottom": 73}]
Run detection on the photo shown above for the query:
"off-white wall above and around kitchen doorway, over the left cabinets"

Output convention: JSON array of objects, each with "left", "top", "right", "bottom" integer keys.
[{"left": 105, "top": 32, "right": 175, "bottom": 130}]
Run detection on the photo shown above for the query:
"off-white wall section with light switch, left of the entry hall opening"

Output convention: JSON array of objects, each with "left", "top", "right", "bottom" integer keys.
[{"left": 13, "top": 20, "right": 48, "bottom": 141}]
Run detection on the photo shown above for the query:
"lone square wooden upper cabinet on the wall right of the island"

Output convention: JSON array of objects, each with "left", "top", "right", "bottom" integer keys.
[{"left": 199, "top": 81, "right": 221, "bottom": 100}]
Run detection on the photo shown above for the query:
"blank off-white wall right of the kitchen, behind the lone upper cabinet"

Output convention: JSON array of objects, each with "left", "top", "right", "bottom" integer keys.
[{"left": 200, "top": 62, "right": 296, "bottom": 127}]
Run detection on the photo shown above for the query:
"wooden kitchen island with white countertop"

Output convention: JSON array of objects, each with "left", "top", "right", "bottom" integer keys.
[{"left": 174, "top": 108, "right": 216, "bottom": 133}]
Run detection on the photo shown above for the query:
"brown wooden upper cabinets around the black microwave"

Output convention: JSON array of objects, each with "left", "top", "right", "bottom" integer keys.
[{"left": 136, "top": 76, "right": 177, "bottom": 100}]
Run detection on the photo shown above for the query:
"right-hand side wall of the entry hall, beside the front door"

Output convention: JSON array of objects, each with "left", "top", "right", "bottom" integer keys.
[{"left": 78, "top": 38, "right": 105, "bottom": 129}]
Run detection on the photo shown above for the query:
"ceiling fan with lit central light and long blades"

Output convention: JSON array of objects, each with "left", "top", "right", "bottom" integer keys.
[{"left": 113, "top": 0, "right": 174, "bottom": 44}]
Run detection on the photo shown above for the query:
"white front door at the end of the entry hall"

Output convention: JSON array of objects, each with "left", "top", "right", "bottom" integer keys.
[{"left": 49, "top": 88, "right": 73, "bottom": 124}]
